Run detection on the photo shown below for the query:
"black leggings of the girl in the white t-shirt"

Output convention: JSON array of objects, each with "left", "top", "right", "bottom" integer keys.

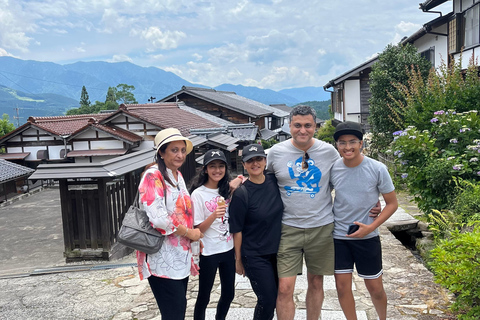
[{"left": 193, "top": 249, "right": 235, "bottom": 320}]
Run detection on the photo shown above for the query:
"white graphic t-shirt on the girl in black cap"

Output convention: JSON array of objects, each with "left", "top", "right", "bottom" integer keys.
[{"left": 191, "top": 186, "right": 233, "bottom": 256}]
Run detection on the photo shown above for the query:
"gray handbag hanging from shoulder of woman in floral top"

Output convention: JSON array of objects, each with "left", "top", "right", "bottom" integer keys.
[{"left": 117, "top": 191, "right": 164, "bottom": 254}]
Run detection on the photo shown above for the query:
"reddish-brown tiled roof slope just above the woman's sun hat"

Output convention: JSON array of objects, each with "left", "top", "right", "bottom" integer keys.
[{"left": 120, "top": 102, "right": 221, "bottom": 136}]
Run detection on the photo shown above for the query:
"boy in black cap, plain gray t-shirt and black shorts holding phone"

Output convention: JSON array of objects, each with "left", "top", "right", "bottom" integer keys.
[{"left": 331, "top": 121, "right": 398, "bottom": 320}]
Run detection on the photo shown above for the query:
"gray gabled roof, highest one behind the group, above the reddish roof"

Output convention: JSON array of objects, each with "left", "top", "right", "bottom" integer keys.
[{"left": 160, "top": 86, "right": 278, "bottom": 118}]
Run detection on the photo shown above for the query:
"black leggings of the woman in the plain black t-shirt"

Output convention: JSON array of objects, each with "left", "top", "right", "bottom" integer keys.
[{"left": 242, "top": 254, "right": 278, "bottom": 320}]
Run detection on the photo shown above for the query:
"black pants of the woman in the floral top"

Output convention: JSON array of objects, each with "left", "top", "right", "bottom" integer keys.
[{"left": 148, "top": 276, "right": 188, "bottom": 320}]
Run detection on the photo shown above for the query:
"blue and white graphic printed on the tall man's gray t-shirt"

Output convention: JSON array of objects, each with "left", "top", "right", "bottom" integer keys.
[{"left": 285, "top": 157, "right": 322, "bottom": 198}]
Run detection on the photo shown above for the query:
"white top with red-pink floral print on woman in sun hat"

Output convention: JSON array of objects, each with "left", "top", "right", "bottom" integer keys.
[{"left": 137, "top": 165, "right": 198, "bottom": 280}]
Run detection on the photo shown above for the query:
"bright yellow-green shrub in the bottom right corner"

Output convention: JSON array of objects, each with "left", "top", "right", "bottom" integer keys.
[{"left": 430, "top": 230, "right": 480, "bottom": 320}]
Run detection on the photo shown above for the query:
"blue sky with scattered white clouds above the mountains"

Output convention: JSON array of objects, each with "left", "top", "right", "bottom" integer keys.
[{"left": 0, "top": 0, "right": 452, "bottom": 90}]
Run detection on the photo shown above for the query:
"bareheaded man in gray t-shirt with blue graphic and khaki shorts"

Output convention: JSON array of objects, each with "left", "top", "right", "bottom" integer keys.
[{"left": 267, "top": 106, "right": 339, "bottom": 320}]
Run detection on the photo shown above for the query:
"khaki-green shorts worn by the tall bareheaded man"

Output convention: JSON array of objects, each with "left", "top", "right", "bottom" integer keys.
[{"left": 277, "top": 223, "right": 335, "bottom": 278}]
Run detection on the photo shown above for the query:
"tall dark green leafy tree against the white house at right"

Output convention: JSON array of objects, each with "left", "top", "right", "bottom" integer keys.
[{"left": 369, "top": 44, "right": 432, "bottom": 153}]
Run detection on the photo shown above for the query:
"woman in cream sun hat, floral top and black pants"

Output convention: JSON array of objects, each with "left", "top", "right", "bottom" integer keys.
[{"left": 137, "top": 128, "right": 203, "bottom": 320}]
